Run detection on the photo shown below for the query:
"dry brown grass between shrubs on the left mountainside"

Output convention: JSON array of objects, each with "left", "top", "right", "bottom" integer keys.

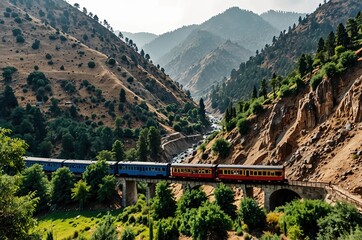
[{"left": 0, "top": 1, "right": 190, "bottom": 127}]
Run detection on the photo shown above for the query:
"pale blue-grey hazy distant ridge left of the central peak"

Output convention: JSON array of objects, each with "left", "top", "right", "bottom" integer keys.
[{"left": 143, "top": 25, "right": 197, "bottom": 63}]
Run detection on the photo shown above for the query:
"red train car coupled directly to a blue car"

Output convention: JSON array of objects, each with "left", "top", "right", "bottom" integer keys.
[{"left": 170, "top": 163, "right": 217, "bottom": 179}]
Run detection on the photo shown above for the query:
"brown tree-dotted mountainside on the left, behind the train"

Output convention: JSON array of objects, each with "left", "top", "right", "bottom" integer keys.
[{"left": 0, "top": 0, "right": 201, "bottom": 159}]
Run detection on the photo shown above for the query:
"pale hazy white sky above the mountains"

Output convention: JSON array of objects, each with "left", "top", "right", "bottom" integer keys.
[{"left": 67, "top": 0, "right": 323, "bottom": 34}]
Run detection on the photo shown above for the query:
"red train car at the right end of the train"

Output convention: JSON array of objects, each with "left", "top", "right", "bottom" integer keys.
[{"left": 217, "top": 164, "right": 285, "bottom": 182}]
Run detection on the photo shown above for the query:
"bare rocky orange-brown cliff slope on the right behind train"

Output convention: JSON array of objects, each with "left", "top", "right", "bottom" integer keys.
[{"left": 192, "top": 59, "right": 362, "bottom": 195}]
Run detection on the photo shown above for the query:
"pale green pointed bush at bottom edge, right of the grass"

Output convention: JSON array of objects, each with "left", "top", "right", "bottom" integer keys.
[{"left": 91, "top": 213, "right": 117, "bottom": 240}]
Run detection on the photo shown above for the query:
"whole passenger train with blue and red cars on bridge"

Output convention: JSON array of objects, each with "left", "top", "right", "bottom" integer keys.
[{"left": 24, "top": 157, "right": 287, "bottom": 183}]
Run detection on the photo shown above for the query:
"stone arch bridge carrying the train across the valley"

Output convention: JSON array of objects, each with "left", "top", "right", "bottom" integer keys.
[{"left": 118, "top": 177, "right": 362, "bottom": 211}]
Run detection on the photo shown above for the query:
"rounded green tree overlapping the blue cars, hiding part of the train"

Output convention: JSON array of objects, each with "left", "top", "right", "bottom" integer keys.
[{"left": 83, "top": 160, "right": 109, "bottom": 198}]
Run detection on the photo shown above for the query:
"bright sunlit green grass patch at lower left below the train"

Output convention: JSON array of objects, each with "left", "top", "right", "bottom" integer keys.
[{"left": 35, "top": 210, "right": 122, "bottom": 240}]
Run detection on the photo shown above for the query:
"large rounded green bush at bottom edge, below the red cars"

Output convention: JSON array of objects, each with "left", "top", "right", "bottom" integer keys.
[{"left": 191, "top": 202, "right": 232, "bottom": 240}]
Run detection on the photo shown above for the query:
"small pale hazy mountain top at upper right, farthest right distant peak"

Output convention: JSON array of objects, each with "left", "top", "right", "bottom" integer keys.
[{"left": 260, "top": 10, "right": 307, "bottom": 31}]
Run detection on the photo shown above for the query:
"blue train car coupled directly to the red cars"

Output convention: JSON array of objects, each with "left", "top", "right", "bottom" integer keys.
[{"left": 118, "top": 162, "right": 170, "bottom": 177}]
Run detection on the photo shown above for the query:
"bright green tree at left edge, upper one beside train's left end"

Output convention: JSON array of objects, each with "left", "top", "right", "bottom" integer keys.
[{"left": 0, "top": 128, "right": 28, "bottom": 174}]
